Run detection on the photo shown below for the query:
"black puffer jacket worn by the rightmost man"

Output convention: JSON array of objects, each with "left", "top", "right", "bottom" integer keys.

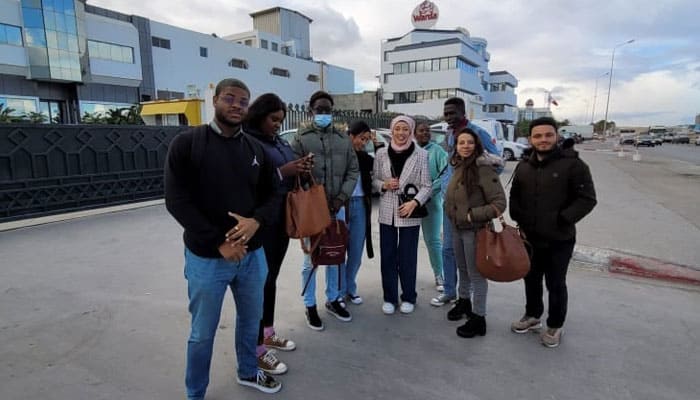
[{"left": 510, "top": 148, "right": 597, "bottom": 243}]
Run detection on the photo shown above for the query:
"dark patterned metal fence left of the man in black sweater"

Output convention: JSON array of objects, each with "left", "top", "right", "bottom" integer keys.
[{"left": 0, "top": 124, "right": 187, "bottom": 222}]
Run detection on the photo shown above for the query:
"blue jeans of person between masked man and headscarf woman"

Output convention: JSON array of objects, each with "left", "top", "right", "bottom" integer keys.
[{"left": 340, "top": 196, "right": 367, "bottom": 297}]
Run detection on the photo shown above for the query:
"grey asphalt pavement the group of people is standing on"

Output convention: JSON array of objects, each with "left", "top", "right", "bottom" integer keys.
[{"left": 0, "top": 206, "right": 700, "bottom": 400}]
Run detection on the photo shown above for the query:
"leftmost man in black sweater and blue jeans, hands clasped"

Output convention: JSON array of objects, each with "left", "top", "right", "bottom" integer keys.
[{"left": 165, "top": 79, "right": 281, "bottom": 400}]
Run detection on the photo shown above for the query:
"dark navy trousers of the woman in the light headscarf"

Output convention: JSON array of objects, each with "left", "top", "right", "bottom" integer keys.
[{"left": 379, "top": 224, "right": 420, "bottom": 304}]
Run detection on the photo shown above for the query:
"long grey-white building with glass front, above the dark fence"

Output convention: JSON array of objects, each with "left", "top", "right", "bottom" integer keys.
[{"left": 0, "top": 0, "right": 354, "bottom": 123}]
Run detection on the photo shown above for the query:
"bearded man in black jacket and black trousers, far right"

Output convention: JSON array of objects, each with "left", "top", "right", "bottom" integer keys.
[{"left": 510, "top": 117, "right": 596, "bottom": 347}]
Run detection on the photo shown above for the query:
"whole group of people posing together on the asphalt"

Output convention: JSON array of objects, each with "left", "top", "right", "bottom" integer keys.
[{"left": 165, "top": 79, "right": 596, "bottom": 400}]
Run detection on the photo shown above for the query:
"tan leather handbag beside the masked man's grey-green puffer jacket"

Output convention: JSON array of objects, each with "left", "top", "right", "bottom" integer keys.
[{"left": 286, "top": 175, "right": 331, "bottom": 239}]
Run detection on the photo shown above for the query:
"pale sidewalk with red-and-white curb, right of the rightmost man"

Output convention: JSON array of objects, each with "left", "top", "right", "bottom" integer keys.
[{"left": 501, "top": 150, "right": 700, "bottom": 284}]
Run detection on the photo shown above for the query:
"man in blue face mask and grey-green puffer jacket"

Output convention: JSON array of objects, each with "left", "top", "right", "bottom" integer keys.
[{"left": 290, "top": 91, "right": 360, "bottom": 331}]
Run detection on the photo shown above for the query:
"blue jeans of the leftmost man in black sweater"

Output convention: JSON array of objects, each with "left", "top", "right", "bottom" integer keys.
[{"left": 185, "top": 248, "right": 267, "bottom": 398}]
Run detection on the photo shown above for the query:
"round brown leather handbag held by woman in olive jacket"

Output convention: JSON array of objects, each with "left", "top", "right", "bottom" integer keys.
[{"left": 476, "top": 204, "right": 530, "bottom": 282}]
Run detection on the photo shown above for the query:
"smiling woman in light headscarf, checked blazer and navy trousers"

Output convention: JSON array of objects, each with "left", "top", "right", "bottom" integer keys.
[{"left": 373, "top": 115, "right": 432, "bottom": 314}]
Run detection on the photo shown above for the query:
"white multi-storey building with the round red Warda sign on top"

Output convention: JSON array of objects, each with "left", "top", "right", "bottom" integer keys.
[{"left": 380, "top": 28, "right": 518, "bottom": 122}]
